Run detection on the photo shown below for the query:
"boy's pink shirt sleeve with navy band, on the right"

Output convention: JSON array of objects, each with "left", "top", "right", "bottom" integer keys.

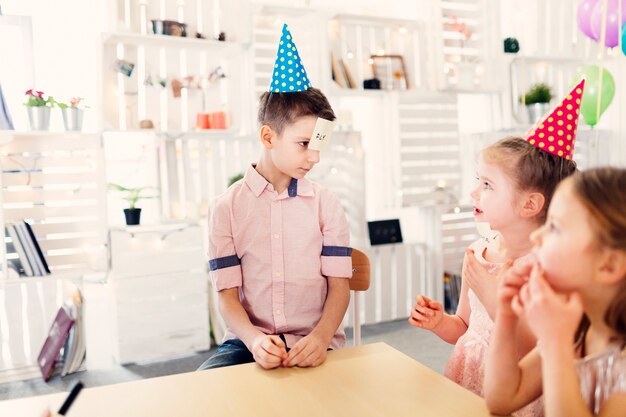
[{"left": 320, "top": 190, "right": 352, "bottom": 278}]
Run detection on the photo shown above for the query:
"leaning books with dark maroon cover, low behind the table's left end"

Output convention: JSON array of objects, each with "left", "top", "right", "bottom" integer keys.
[{"left": 37, "top": 290, "right": 86, "bottom": 381}]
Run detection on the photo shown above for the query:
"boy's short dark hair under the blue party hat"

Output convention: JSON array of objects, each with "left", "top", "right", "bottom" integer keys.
[{"left": 258, "top": 88, "right": 336, "bottom": 135}]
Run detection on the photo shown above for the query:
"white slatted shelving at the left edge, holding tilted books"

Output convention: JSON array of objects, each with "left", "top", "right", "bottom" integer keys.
[{"left": 0, "top": 131, "right": 107, "bottom": 382}]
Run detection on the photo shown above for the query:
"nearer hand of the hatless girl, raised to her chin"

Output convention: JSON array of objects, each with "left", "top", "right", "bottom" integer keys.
[{"left": 512, "top": 265, "right": 583, "bottom": 345}]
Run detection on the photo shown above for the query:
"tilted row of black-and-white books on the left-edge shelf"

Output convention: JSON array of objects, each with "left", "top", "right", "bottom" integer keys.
[{"left": 6, "top": 220, "right": 50, "bottom": 277}]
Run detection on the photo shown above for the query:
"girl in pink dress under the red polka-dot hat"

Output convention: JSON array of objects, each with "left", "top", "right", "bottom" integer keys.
[{"left": 409, "top": 138, "right": 576, "bottom": 416}]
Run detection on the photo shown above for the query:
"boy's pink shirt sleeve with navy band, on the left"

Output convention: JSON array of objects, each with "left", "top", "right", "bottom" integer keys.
[{"left": 209, "top": 199, "right": 242, "bottom": 291}]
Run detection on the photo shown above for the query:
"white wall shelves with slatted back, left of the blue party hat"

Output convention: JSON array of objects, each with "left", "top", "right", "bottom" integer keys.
[{"left": 102, "top": 0, "right": 250, "bottom": 132}]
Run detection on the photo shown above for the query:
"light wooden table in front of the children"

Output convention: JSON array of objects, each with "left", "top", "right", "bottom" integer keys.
[{"left": 0, "top": 343, "right": 498, "bottom": 417}]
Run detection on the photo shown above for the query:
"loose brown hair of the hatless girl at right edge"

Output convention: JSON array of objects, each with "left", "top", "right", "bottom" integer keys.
[{"left": 568, "top": 168, "right": 626, "bottom": 343}]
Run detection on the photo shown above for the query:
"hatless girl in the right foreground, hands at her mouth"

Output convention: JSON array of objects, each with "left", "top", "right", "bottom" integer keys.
[{"left": 485, "top": 168, "right": 626, "bottom": 417}]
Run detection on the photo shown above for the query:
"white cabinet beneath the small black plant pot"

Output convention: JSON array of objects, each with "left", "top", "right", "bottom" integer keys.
[{"left": 107, "top": 223, "right": 210, "bottom": 363}]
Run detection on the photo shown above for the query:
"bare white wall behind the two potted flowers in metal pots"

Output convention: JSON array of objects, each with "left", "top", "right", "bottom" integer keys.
[{"left": 0, "top": 0, "right": 107, "bottom": 131}]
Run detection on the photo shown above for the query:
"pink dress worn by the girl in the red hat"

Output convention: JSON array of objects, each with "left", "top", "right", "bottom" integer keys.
[{"left": 444, "top": 239, "right": 543, "bottom": 417}]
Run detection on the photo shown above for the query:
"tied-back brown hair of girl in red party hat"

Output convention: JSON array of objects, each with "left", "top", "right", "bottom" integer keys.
[{"left": 483, "top": 136, "right": 577, "bottom": 224}]
